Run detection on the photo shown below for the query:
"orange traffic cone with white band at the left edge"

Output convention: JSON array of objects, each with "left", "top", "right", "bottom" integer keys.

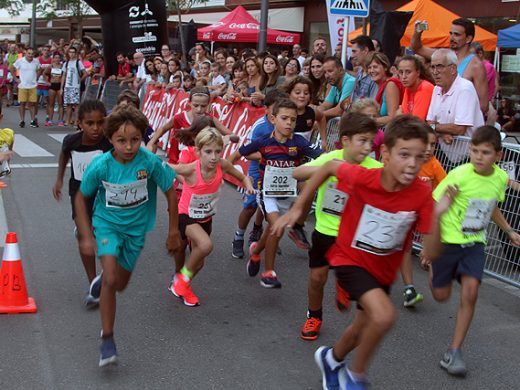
[{"left": 0, "top": 232, "right": 36, "bottom": 314}]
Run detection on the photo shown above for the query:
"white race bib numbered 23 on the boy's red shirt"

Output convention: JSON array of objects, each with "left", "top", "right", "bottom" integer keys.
[{"left": 352, "top": 204, "right": 416, "bottom": 256}]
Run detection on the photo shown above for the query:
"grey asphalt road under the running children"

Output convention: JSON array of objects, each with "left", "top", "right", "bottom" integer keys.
[{"left": 0, "top": 108, "right": 520, "bottom": 390}]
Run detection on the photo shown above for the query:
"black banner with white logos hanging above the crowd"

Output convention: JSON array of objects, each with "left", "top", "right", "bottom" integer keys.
[{"left": 85, "top": 0, "right": 168, "bottom": 75}]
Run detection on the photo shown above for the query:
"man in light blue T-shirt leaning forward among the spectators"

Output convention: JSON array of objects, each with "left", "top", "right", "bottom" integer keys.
[{"left": 319, "top": 56, "right": 356, "bottom": 120}]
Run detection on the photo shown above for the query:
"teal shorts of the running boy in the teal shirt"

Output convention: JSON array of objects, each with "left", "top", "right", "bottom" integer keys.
[{"left": 94, "top": 227, "right": 145, "bottom": 272}]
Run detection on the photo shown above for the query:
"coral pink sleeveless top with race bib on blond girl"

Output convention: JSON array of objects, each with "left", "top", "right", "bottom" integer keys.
[{"left": 179, "top": 160, "right": 223, "bottom": 222}]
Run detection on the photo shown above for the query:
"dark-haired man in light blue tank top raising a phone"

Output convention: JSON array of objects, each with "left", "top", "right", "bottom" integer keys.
[{"left": 411, "top": 18, "right": 489, "bottom": 113}]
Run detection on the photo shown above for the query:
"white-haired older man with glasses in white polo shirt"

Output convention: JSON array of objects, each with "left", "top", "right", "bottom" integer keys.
[{"left": 426, "top": 49, "right": 484, "bottom": 163}]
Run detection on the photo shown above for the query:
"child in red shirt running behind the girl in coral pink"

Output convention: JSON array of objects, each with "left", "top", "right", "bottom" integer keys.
[{"left": 146, "top": 87, "right": 231, "bottom": 164}]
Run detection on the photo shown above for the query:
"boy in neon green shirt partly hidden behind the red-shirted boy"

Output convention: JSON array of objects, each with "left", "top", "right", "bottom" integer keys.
[{"left": 293, "top": 113, "right": 383, "bottom": 340}]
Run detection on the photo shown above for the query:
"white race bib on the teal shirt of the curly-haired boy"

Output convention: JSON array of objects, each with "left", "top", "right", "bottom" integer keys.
[{"left": 103, "top": 179, "right": 148, "bottom": 209}]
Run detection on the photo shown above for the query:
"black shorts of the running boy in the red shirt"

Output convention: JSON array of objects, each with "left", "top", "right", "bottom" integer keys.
[{"left": 334, "top": 265, "right": 390, "bottom": 309}]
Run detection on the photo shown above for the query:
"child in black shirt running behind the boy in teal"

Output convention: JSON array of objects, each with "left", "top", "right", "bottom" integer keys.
[{"left": 52, "top": 100, "right": 112, "bottom": 309}]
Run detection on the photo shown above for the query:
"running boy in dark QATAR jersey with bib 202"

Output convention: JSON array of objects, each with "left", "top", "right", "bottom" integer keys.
[{"left": 238, "top": 99, "right": 322, "bottom": 288}]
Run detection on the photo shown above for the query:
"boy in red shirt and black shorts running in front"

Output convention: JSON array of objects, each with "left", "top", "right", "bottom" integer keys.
[{"left": 273, "top": 116, "right": 449, "bottom": 389}]
